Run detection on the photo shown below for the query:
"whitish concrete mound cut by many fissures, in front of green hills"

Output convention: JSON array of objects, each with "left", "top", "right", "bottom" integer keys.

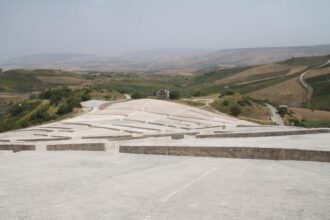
[{"left": 0, "top": 99, "right": 252, "bottom": 145}]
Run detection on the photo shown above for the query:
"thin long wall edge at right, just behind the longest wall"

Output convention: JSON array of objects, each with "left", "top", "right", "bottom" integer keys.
[{"left": 196, "top": 129, "right": 330, "bottom": 138}]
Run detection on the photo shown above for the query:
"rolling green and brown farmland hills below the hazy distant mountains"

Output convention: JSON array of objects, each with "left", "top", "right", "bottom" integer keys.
[{"left": 0, "top": 55, "right": 330, "bottom": 110}]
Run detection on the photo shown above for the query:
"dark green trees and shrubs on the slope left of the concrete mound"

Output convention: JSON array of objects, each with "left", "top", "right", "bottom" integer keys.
[{"left": 0, "top": 87, "right": 91, "bottom": 132}]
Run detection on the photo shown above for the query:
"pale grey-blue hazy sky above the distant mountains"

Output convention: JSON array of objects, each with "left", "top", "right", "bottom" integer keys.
[{"left": 0, "top": 0, "right": 330, "bottom": 58}]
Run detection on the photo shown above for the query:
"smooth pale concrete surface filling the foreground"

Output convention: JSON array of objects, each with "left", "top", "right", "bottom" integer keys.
[{"left": 0, "top": 151, "right": 330, "bottom": 220}]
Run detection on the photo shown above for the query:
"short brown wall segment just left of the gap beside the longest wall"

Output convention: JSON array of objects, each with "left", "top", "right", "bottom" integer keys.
[{"left": 47, "top": 143, "right": 105, "bottom": 151}]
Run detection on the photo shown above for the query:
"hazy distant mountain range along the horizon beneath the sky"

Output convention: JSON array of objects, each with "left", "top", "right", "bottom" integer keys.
[{"left": 0, "top": 44, "right": 330, "bottom": 73}]
